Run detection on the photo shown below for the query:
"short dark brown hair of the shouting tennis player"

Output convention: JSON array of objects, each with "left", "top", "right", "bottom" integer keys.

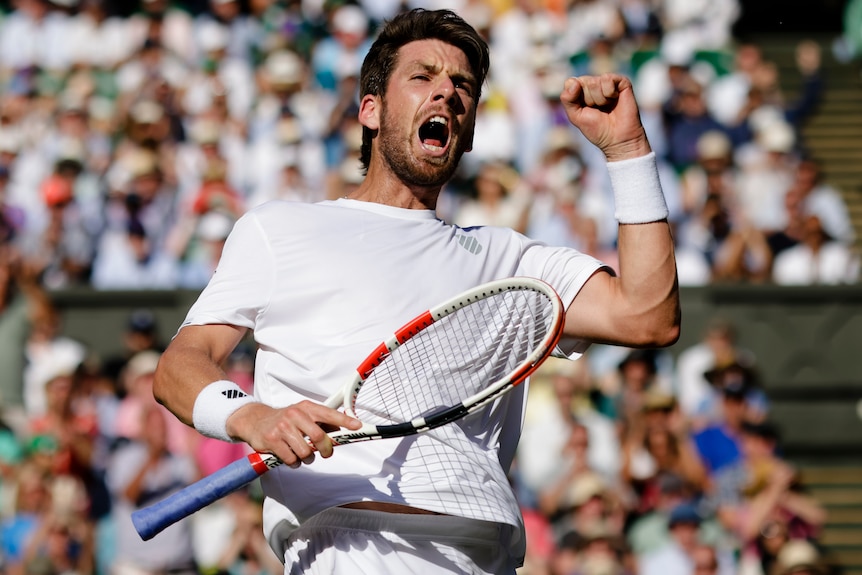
[{"left": 359, "top": 8, "right": 490, "bottom": 170}]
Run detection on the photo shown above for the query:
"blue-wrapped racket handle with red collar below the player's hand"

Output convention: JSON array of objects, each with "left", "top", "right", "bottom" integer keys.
[{"left": 132, "top": 453, "right": 281, "bottom": 541}]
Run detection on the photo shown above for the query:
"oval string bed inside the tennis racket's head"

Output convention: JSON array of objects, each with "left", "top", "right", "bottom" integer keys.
[{"left": 354, "top": 290, "right": 553, "bottom": 425}]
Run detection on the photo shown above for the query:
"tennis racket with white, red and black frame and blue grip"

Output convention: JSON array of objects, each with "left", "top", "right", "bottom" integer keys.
[{"left": 132, "top": 277, "right": 564, "bottom": 540}]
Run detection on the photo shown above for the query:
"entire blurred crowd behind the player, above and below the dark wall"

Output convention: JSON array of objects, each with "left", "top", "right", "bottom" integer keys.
[{"left": 0, "top": 0, "right": 859, "bottom": 575}]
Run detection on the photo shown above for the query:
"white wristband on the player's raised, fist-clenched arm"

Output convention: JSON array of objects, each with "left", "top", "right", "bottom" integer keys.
[{"left": 608, "top": 152, "right": 670, "bottom": 224}]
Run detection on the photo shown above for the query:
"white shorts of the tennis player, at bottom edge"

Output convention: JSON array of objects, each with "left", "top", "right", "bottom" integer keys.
[{"left": 284, "top": 507, "right": 520, "bottom": 575}]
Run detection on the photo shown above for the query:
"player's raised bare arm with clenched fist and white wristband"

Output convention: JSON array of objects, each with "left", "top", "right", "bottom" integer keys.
[{"left": 560, "top": 74, "right": 680, "bottom": 347}]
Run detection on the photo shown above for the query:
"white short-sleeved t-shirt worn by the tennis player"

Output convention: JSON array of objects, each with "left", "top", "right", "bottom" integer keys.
[{"left": 183, "top": 199, "right": 602, "bottom": 551}]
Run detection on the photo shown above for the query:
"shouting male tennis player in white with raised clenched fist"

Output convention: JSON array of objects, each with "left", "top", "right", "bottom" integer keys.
[{"left": 155, "top": 10, "right": 680, "bottom": 575}]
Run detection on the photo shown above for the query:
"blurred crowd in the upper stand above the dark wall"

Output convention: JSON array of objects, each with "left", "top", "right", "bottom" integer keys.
[{"left": 0, "top": 0, "right": 859, "bottom": 289}]
